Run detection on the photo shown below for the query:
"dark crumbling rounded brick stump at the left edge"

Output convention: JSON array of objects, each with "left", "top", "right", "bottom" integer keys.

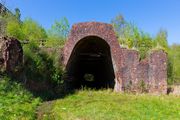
[{"left": 0, "top": 37, "right": 23, "bottom": 75}]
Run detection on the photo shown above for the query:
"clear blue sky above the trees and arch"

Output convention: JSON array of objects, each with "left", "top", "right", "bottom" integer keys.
[{"left": 1, "top": 0, "right": 180, "bottom": 45}]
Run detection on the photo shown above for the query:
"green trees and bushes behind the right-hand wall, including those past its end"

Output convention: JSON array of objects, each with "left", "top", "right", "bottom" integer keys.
[{"left": 111, "top": 15, "right": 180, "bottom": 84}]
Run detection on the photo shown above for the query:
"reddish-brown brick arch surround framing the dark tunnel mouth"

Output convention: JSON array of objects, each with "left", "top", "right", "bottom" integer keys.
[{"left": 63, "top": 22, "right": 122, "bottom": 91}]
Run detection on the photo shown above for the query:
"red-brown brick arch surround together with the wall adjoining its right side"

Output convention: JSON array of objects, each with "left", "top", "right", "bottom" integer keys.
[{"left": 62, "top": 22, "right": 167, "bottom": 94}]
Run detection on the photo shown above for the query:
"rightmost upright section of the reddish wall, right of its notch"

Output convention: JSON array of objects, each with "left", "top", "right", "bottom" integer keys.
[{"left": 149, "top": 50, "right": 167, "bottom": 93}]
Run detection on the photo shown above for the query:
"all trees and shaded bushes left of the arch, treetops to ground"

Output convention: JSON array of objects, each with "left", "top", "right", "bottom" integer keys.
[{"left": 1, "top": 9, "right": 69, "bottom": 100}]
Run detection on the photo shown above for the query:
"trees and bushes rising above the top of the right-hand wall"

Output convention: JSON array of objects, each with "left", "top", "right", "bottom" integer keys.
[{"left": 111, "top": 15, "right": 168, "bottom": 59}]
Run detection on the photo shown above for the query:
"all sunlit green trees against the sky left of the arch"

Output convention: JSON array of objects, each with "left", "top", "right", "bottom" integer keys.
[{"left": 0, "top": 8, "right": 70, "bottom": 47}]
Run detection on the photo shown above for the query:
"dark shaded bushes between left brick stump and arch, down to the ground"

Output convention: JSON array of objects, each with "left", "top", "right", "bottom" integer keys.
[{"left": 23, "top": 42, "right": 64, "bottom": 100}]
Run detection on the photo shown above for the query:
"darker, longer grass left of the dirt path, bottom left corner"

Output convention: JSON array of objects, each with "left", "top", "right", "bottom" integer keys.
[{"left": 0, "top": 78, "right": 40, "bottom": 120}]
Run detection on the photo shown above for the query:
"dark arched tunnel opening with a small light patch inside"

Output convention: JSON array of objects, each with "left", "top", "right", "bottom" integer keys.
[{"left": 66, "top": 36, "right": 115, "bottom": 89}]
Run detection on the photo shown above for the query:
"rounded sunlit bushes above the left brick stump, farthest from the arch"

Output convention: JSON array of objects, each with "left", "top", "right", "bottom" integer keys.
[{"left": 2, "top": 8, "right": 47, "bottom": 44}]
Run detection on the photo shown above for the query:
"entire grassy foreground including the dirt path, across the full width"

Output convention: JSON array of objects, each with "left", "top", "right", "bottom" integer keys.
[{"left": 0, "top": 78, "right": 180, "bottom": 120}]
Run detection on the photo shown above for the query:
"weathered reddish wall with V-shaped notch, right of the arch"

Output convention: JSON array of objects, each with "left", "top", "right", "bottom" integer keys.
[{"left": 121, "top": 49, "right": 167, "bottom": 94}]
